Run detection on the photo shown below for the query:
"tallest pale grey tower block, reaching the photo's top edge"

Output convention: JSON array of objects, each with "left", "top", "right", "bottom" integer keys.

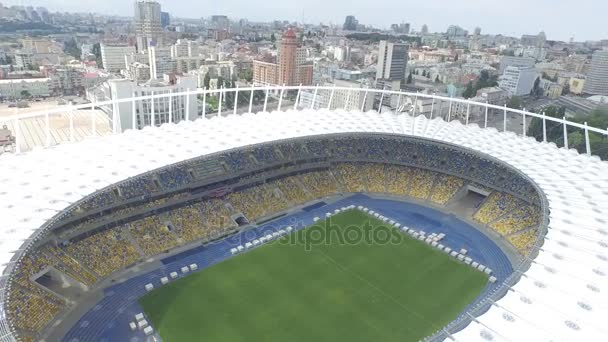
[{"left": 133, "top": 0, "right": 163, "bottom": 51}]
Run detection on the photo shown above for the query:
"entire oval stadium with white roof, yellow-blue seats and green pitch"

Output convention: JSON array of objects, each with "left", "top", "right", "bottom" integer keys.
[{"left": 0, "top": 87, "right": 608, "bottom": 342}]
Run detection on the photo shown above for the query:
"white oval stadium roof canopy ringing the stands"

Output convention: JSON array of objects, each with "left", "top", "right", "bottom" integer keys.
[{"left": 0, "top": 110, "right": 608, "bottom": 342}]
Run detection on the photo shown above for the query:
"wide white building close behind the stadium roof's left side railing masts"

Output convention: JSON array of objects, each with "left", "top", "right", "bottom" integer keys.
[{"left": 106, "top": 75, "right": 198, "bottom": 131}]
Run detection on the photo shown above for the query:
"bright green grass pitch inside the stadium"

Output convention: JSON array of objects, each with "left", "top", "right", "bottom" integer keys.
[{"left": 140, "top": 211, "right": 487, "bottom": 342}]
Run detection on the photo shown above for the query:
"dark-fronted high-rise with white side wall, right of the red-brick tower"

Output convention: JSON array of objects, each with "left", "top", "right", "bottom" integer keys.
[{"left": 376, "top": 40, "right": 409, "bottom": 81}]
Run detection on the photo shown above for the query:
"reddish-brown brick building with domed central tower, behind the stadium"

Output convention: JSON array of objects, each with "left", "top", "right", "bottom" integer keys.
[{"left": 253, "top": 28, "right": 313, "bottom": 86}]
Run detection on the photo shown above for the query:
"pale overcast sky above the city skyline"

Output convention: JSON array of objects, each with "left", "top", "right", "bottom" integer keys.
[{"left": 0, "top": 0, "right": 608, "bottom": 41}]
